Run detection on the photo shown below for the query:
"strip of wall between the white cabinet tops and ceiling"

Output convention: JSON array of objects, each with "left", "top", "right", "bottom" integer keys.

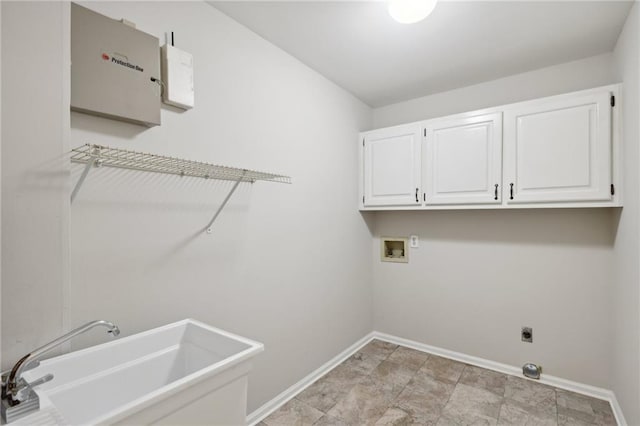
[{"left": 373, "top": 53, "right": 613, "bottom": 128}]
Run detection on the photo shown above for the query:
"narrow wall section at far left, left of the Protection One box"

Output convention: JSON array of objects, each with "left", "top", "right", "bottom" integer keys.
[{"left": 0, "top": 2, "right": 69, "bottom": 368}]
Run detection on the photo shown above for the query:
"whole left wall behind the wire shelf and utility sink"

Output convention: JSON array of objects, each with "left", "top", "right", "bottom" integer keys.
[{"left": 2, "top": 2, "right": 372, "bottom": 411}]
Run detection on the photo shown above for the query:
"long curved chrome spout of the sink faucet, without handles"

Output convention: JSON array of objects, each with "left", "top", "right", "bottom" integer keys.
[{"left": 3, "top": 320, "right": 120, "bottom": 403}]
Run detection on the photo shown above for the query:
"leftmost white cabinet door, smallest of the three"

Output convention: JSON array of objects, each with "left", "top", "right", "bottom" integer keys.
[{"left": 363, "top": 124, "right": 421, "bottom": 206}]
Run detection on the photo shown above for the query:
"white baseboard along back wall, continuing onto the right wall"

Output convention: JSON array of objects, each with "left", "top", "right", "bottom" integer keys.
[{"left": 373, "top": 331, "right": 627, "bottom": 426}]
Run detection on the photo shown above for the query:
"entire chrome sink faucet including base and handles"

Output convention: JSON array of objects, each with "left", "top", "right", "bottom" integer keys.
[{"left": 2, "top": 320, "right": 120, "bottom": 422}]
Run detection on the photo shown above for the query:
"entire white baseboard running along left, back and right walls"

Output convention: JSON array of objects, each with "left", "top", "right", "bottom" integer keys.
[{"left": 247, "top": 331, "right": 627, "bottom": 426}]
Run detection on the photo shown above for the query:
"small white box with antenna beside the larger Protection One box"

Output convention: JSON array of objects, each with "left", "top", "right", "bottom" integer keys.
[{"left": 160, "top": 44, "right": 194, "bottom": 109}]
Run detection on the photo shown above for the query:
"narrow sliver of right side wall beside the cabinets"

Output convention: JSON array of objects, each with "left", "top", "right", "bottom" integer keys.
[{"left": 611, "top": 3, "right": 640, "bottom": 425}]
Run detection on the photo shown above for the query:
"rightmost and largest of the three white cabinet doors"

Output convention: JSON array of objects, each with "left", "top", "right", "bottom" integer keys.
[{"left": 504, "top": 91, "right": 612, "bottom": 204}]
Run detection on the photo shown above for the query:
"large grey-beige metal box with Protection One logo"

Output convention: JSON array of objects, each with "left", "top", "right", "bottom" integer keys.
[{"left": 71, "top": 3, "right": 161, "bottom": 126}]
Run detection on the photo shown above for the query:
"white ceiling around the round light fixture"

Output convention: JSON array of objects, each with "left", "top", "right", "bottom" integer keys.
[{"left": 209, "top": 1, "right": 632, "bottom": 107}]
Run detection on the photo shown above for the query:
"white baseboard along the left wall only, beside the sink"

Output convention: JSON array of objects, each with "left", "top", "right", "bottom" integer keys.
[{"left": 247, "top": 333, "right": 374, "bottom": 426}]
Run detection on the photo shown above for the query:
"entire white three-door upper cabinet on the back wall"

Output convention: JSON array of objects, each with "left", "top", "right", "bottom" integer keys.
[{"left": 360, "top": 85, "right": 622, "bottom": 210}]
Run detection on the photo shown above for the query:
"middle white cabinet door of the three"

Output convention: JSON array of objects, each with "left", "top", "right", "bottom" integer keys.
[{"left": 425, "top": 113, "right": 502, "bottom": 204}]
